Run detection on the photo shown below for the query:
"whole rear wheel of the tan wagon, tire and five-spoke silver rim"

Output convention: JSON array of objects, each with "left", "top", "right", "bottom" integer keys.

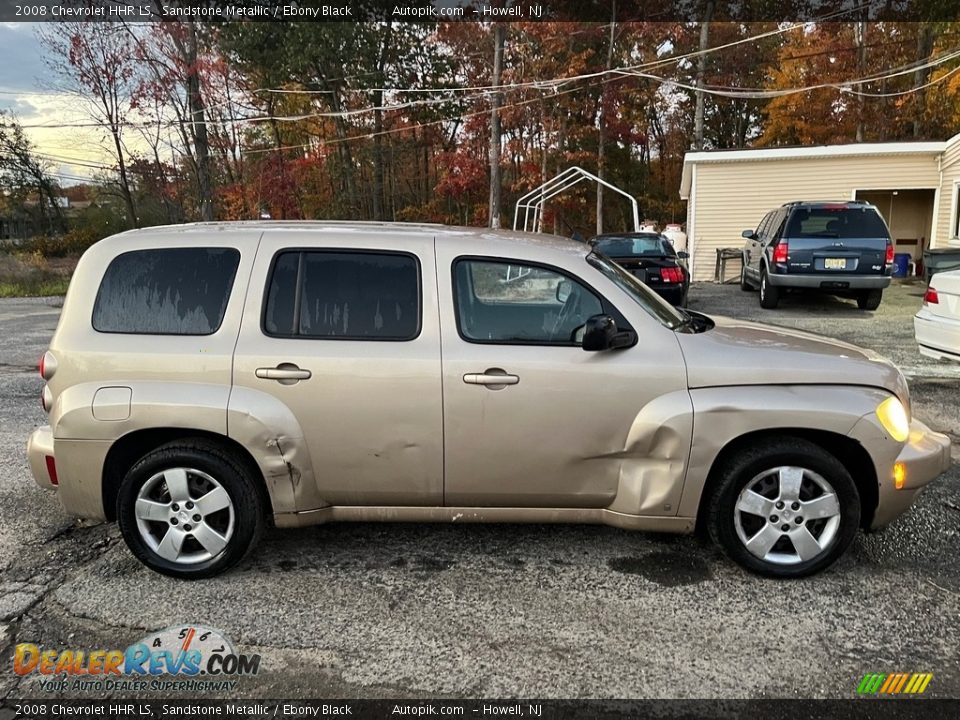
[{"left": 117, "top": 441, "right": 264, "bottom": 579}]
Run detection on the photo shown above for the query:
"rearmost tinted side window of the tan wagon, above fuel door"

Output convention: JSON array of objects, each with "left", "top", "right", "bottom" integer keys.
[{"left": 93, "top": 248, "right": 240, "bottom": 335}]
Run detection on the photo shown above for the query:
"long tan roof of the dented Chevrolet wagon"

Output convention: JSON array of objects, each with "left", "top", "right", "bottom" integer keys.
[{"left": 98, "top": 220, "right": 590, "bottom": 259}]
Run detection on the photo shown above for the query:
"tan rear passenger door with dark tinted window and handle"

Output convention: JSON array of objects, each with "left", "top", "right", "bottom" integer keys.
[{"left": 231, "top": 228, "right": 443, "bottom": 510}]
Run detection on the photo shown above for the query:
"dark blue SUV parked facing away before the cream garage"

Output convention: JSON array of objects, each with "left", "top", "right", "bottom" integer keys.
[{"left": 740, "top": 202, "right": 893, "bottom": 310}]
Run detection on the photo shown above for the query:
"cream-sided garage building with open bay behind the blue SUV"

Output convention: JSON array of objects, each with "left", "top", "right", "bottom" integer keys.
[{"left": 680, "top": 135, "right": 960, "bottom": 280}]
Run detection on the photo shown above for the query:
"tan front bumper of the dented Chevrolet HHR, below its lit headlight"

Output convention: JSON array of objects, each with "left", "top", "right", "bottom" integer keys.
[{"left": 870, "top": 420, "right": 952, "bottom": 530}]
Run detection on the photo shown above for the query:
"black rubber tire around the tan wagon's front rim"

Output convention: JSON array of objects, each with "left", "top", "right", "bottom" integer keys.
[{"left": 705, "top": 437, "right": 860, "bottom": 578}]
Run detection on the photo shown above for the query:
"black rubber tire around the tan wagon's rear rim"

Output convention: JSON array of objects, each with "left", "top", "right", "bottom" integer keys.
[{"left": 117, "top": 439, "right": 265, "bottom": 580}]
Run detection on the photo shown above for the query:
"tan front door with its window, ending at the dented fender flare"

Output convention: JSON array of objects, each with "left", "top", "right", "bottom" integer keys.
[{"left": 437, "top": 252, "right": 662, "bottom": 508}]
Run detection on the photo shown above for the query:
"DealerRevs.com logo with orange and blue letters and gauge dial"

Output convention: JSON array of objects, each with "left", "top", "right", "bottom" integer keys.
[{"left": 13, "top": 625, "right": 260, "bottom": 692}]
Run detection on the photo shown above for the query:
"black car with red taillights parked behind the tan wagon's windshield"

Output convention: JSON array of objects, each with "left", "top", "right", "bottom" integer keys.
[{"left": 590, "top": 232, "right": 690, "bottom": 307}]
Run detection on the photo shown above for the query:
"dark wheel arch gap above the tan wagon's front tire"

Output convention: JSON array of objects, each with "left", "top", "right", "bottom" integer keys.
[{"left": 696, "top": 427, "right": 880, "bottom": 536}]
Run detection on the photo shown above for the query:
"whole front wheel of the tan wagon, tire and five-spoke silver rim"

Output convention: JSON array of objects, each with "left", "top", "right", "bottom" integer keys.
[{"left": 708, "top": 438, "right": 860, "bottom": 578}]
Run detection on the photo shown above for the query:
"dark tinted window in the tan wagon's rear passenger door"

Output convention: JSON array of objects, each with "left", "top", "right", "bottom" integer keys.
[{"left": 263, "top": 250, "right": 420, "bottom": 340}]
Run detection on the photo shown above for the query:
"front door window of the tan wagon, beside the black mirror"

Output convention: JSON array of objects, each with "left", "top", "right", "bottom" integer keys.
[{"left": 454, "top": 260, "right": 603, "bottom": 345}]
